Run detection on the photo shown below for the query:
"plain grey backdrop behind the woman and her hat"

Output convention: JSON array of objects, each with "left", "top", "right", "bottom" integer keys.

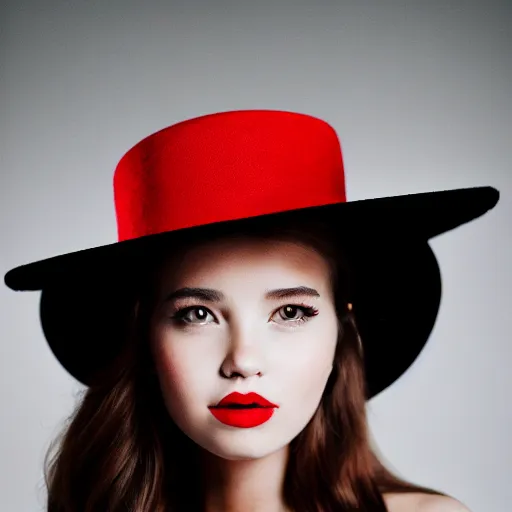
[{"left": 0, "top": 0, "right": 512, "bottom": 512}]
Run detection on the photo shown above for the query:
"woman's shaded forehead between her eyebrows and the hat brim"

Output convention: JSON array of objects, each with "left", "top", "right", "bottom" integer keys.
[{"left": 155, "top": 237, "right": 329, "bottom": 284}]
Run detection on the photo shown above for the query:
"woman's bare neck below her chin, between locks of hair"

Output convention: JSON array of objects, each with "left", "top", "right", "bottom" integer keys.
[{"left": 202, "top": 447, "right": 288, "bottom": 512}]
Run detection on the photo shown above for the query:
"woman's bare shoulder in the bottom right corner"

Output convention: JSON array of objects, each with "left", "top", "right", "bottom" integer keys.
[{"left": 384, "top": 492, "right": 471, "bottom": 512}]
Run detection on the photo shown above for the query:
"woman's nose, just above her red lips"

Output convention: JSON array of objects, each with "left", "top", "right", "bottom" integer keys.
[{"left": 220, "top": 330, "right": 264, "bottom": 379}]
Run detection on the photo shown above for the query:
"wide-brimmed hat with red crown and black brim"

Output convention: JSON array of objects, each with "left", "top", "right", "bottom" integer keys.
[{"left": 5, "top": 110, "right": 499, "bottom": 398}]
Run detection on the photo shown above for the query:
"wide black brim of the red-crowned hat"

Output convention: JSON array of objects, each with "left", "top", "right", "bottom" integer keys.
[{"left": 5, "top": 187, "right": 499, "bottom": 399}]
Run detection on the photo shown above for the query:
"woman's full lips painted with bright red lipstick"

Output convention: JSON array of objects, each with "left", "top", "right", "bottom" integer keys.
[{"left": 209, "top": 392, "right": 279, "bottom": 428}]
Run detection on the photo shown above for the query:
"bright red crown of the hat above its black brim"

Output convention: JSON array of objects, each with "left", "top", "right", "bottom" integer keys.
[{"left": 114, "top": 110, "right": 346, "bottom": 241}]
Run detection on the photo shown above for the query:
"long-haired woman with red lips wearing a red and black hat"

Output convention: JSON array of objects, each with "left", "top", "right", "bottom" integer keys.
[{"left": 5, "top": 111, "right": 498, "bottom": 512}]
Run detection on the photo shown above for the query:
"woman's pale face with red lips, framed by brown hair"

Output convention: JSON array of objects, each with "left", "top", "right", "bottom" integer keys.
[{"left": 150, "top": 239, "right": 337, "bottom": 460}]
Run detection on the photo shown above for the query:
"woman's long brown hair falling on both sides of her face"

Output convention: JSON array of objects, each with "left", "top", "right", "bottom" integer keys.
[{"left": 45, "top": 218, "right": 441, "bottom": 512}]
